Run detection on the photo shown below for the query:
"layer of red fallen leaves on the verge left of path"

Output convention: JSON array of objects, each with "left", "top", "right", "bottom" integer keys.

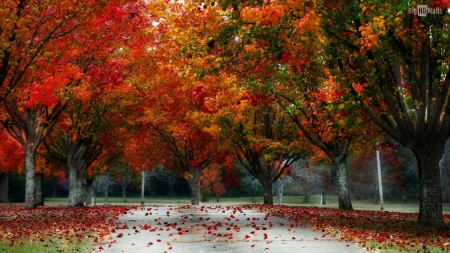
[{"left": 0, "top": 204, "right": 129, "bottom": 246}]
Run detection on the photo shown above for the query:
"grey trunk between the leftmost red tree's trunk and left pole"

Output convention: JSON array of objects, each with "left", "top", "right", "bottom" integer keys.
[{"left": 68, "top": 162, "right": 84, "bottom": 207}]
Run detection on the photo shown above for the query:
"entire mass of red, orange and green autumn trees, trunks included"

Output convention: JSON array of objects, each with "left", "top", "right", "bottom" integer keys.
[{"left": 0, "top": 0, "right": 450, "bottom": 226}]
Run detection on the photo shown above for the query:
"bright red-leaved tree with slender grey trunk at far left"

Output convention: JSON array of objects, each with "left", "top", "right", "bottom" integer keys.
[{"left": 3, "top": 1, "right": 149, "bottom": 208}]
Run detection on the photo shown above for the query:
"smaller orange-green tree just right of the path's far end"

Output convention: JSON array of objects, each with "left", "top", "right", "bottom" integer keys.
[{"left": 217, "top": 100, "right": 306, "bottom": 204}]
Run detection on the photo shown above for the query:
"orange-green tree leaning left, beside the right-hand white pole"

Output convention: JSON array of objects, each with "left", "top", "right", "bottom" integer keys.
[{"left": 196, "top": 1, "right": 380, "bottom": 210}]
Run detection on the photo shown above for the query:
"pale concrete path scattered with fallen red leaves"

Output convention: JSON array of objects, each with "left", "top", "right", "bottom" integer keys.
[{"left": 94, "top": 205, "right": 367, "bottom": 253}]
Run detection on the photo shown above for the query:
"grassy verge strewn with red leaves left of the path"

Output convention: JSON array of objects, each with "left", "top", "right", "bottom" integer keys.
[{"left": 0, "top": 204, "right": 130, "bottom": 253}]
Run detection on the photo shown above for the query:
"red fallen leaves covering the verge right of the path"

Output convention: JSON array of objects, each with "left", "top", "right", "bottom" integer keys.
[{"left": 253, "top": 205, "right": 450, "bottom": 252}]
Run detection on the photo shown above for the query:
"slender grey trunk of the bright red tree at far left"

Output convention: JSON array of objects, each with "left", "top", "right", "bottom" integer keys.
[{"left": 25, "top": 149, "right": 36, "bottom": 209}]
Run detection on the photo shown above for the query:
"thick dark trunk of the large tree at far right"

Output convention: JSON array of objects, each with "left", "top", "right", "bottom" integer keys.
[{"left": 415, "top": 150, "right": 446, "bottom": 227}]
